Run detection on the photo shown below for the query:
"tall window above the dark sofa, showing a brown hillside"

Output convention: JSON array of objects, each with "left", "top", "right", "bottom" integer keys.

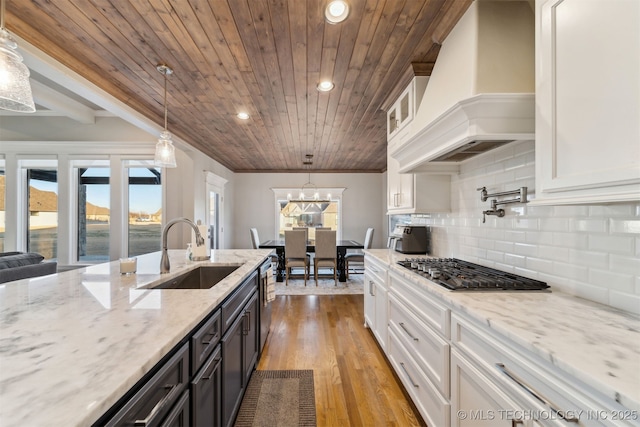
[{"left": 26, "top": 168, "right": 58, "bottom": 260}]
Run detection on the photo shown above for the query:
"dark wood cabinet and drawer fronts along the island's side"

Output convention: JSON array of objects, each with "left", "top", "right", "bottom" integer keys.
[{"left": 94, "top": 262, "right": 260, "bottom": 426}]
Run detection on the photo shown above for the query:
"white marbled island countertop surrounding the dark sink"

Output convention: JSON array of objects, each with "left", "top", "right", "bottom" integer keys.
[{"left": 0, "top": 249, "right": 270, "bottom": 427}]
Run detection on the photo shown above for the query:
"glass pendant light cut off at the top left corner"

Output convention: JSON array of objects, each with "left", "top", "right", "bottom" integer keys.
[{"left": 0, "top": 0, "right": 36, "bottom": 113}]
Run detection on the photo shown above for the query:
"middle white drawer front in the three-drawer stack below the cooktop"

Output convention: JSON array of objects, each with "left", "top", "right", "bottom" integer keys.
[{"left": 389, "top": 296, "right": 450, "bottom": 397}]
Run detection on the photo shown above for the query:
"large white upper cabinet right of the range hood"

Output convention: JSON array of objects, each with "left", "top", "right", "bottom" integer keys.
[{"left": 532, "top": 0, "right": 640, "bottom": 204}]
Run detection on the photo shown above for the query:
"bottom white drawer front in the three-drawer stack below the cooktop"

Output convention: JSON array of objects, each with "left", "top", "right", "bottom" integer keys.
[{"left": 389, "top": 330, "right": 451, "bottom": 426}]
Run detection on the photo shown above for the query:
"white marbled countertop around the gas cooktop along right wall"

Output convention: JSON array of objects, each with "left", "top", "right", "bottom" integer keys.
[{"left": 365, "top": 249, "right": 640, "bottom": 411}]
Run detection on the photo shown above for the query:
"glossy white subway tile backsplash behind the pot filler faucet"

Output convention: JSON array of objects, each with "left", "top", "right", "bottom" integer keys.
[{"left": 412, "top": 141, "right": 640, "bottom": 314}]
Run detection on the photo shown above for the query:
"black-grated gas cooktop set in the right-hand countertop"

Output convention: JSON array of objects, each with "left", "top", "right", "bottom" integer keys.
[{"left": 398, "top": 258, "right": 549, "bottom": 291}]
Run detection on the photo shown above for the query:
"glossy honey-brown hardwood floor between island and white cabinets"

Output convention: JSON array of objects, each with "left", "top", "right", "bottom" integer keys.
[{"left": 257, "top": 295, "right": 424, "bottom": 427}]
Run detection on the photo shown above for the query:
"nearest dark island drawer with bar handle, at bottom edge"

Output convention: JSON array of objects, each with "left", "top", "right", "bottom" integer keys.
[{"left": 105, "top": 343, "right": 189, "bottom": 426}]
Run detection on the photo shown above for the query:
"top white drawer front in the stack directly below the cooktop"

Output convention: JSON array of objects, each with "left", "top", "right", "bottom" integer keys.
[{"left": 389, "top": 271, "right": 450, "bottom": 338}]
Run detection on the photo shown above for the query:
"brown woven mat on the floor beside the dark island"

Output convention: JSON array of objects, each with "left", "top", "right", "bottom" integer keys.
[{"left": 235, "top": 370, "right": 316, "bottom": 427}]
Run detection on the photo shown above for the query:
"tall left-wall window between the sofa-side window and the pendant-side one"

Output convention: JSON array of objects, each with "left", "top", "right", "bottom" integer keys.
[{"left": 75, "top": 166, "right": 111, "bottom": 262}]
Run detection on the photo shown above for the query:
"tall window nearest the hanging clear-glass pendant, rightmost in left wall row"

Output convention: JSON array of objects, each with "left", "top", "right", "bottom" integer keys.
[{"left": 127, "top": 164, "right": 162, "bottom": 256}]
